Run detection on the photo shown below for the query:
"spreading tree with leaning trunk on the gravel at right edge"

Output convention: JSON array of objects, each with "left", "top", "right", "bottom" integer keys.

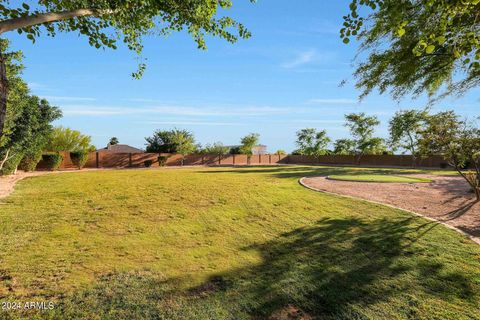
[{"left": 419, "top": 111, "right": 480, "bottom": 201}]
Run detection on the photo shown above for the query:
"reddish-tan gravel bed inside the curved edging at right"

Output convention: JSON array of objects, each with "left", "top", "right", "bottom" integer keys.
[{"left": 302, "top": 175, "right": 480, "bottom": 243}]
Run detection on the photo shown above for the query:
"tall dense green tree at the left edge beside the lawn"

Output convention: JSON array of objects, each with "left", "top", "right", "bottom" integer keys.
[{"left": 0, "top": 40, "right": 61, "bottom": 174}]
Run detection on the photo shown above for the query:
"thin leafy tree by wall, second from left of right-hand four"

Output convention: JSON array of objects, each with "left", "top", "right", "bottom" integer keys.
[{"left": 345, "top": 112, "right": 387, "bottom": 162}]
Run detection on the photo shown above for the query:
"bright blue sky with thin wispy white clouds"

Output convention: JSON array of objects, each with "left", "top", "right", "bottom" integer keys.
[{"left": 4, "top": 0, "right": 480, "bottom": 152}]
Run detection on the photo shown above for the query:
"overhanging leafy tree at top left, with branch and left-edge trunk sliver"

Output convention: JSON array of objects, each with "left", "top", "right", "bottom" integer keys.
[{"left": 0, "top": 0, "right": 255, "bottom": 138}]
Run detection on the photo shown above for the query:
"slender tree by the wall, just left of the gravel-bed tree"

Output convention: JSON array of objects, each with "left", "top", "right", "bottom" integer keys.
[{"left": 389, "top": 110, "right": 428, "bottom": 166}]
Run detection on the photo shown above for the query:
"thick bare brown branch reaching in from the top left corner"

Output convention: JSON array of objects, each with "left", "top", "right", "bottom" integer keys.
[{"left": 0, "top": 8, "right": 105, "bottom": 34}]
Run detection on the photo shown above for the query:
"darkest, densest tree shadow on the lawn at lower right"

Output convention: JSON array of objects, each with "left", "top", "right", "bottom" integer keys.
[{"left": 203, "top": 218, "right": 474, "bottom": 319}]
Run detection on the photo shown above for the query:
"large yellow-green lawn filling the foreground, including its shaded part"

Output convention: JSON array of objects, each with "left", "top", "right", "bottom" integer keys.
[{"left": 0, "top": 167, "right": 480, "bottom": 319}]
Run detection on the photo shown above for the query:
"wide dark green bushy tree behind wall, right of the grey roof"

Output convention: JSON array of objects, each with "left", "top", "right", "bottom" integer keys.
[{"left": 145, "top": 129, "right": 197, "bottom": 154}]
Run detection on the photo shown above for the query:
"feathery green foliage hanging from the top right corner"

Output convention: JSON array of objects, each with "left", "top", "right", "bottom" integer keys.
[{"left": 340, "top": 0, "right": 480, "bottom": 99}]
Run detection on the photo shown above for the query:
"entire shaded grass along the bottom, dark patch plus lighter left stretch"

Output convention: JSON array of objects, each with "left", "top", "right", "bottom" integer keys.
[{"left": 18, "top": 217, "right": 479, "bottom": 319}]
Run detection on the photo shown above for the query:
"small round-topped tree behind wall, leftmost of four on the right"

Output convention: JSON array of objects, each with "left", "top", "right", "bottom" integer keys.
[{"left": 294, "top": 128, "right": 331, "bottom": 156}]
